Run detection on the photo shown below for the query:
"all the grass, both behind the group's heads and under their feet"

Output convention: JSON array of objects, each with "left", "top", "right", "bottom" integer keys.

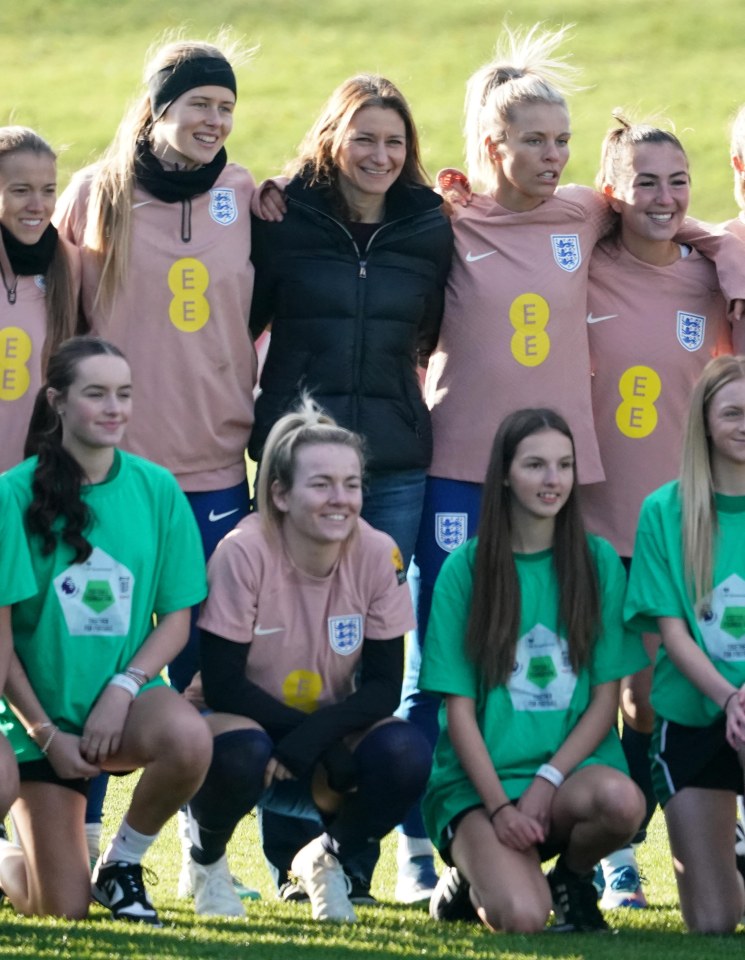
[{"left": 0, "top": 0, "right": 745, "bottom": 960}]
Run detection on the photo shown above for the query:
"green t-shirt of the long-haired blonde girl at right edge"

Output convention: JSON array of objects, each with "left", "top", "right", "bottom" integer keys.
[{"left": 624, "top": 480, "right": 745, "bottom": 727}]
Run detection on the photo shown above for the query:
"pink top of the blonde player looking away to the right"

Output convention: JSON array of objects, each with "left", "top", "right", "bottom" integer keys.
[{"left": 426, "top": 186, "right": 609, "bottom": 483}]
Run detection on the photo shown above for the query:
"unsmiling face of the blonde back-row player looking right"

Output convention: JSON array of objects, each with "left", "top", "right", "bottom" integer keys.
[{"left": 489, "top": 103, "right": 571, "bottom": 212}]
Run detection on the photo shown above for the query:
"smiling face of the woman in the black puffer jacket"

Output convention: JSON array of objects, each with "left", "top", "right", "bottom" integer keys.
[{"left": 334, "top": 107, "right": 406, "bottom": 223}]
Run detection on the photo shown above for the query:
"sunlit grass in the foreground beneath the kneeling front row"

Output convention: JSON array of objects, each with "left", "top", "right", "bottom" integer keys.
[{"left": 0, "top": 778, "right": 743, "bottom": 960}]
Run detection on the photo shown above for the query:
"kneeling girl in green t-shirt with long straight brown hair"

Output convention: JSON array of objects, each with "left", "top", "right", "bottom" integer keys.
[{"left": 420, "top": 409, "right": 646, "bottom": 933}]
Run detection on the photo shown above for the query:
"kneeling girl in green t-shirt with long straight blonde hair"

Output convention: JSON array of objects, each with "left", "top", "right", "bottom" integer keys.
[{"left": 625, "top": 356, "right": 745, "bottom": 933}]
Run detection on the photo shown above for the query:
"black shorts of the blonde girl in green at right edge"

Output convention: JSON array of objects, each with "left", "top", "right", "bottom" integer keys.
[{"left": 649, "top": 716, "right": 743, "bottom": 807}]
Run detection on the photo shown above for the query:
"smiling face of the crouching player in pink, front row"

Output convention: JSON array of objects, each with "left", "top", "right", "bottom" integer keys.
[{"left": 271, "top": 443, "right": 362, "bottom": 559}]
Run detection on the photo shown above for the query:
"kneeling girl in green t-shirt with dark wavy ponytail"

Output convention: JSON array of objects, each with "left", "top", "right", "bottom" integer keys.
[{"left": 0, "top": 337, "right": 211, "bottom": 925}]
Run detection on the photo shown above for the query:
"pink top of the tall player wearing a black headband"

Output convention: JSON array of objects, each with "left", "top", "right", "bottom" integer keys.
[{"left": 56, "top": 164, "right": 257, "bottom": 492}]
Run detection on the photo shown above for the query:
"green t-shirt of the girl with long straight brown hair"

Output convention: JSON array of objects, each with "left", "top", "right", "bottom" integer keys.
[{"left": 419, "top": 536, "right": 647, "bottom": 847}]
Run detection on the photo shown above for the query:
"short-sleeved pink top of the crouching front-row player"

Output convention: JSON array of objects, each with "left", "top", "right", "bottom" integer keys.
[{"left": 199, "top": 514, "right": 415, "bottom": 713}]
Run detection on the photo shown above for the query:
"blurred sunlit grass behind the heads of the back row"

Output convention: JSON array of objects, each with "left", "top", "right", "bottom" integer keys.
[{"left": 0, "top": 0, "right": 745, "bottom": 220}]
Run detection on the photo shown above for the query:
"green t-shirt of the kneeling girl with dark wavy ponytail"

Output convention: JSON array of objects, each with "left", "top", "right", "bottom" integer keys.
[{"left": 3, "top": 451, "right": 207, "bottom": 761}]
